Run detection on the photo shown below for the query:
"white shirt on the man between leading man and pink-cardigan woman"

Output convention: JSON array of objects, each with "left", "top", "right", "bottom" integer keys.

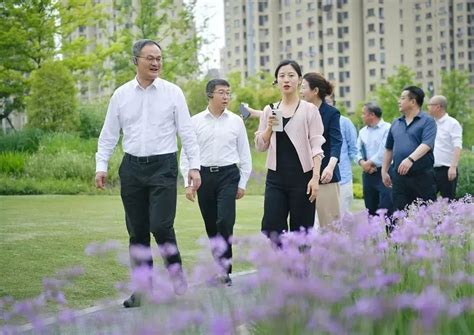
[{"left": 180, "top": 109, "right": 252, "bottom": 189}]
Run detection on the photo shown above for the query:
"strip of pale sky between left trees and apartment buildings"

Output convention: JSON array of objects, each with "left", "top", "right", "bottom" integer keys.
[{"left": 194, "top": 0, "right": 225, "bottom": 73}]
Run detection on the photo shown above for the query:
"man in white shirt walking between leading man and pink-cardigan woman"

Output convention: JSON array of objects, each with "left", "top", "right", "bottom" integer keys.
[{"left": 180, "top": 79, "right": 252, "bottom": 285}]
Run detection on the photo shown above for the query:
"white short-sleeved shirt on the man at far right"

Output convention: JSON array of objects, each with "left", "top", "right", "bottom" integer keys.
[{"left": 433, "top": 114, "right": 462, "bottom": 167}]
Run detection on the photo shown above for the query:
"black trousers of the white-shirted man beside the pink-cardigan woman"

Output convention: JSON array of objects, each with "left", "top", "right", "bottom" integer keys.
[{"left": 198, "top": 164, "right": 240, "bottom": 273}]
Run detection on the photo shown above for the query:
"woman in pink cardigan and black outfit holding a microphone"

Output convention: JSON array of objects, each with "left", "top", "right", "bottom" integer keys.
[{"left": 255, "top": 60, "right": 325, "bottom": 245}]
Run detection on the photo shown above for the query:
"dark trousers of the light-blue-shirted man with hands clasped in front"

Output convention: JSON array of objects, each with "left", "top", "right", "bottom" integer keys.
[{"left": 362, "top": 169, "right": 393, "bottom": 216}]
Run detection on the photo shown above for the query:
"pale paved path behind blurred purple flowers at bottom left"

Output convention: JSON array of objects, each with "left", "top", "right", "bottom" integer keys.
[{"left": 20, "top": 271, "right": 256, "bottom": 335}]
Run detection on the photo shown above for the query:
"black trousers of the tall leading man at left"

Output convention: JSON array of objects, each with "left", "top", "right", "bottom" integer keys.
[{"left": 119, "top": 153, "right": 181, "bottom": 266}]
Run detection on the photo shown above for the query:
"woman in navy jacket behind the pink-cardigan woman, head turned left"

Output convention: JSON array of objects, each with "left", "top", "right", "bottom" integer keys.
[{"left": 301, "top": 72, "right": 342, "bottom": 227}]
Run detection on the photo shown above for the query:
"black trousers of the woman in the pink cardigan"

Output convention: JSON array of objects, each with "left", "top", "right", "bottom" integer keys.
[{"left": 262, "top": 170, "right": 316, "bottom": 245}]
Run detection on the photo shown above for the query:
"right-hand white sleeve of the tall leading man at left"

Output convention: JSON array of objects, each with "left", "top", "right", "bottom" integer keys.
[{"left": 175, "top": 90, "right": 201, "bottom": 170}]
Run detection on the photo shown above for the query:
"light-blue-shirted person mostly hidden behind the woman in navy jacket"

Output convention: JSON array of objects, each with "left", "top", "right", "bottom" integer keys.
[{"left": 325, "top": 92, "right": 357, "bottom": 213}]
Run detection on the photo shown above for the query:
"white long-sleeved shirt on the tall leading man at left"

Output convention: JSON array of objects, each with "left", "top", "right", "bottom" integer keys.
[{"left": 96, "top": 78, "right": 200, "bottom": 172}]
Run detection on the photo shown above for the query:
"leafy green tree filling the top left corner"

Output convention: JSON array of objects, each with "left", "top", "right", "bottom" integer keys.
[{"left": 0, "top": 0, "right": 107, "bottom": 115}]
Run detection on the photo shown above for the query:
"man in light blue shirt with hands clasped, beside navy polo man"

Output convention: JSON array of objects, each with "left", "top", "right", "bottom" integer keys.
[{"left": 355, "top": 102, "right": 393, "bottom": 216}]
